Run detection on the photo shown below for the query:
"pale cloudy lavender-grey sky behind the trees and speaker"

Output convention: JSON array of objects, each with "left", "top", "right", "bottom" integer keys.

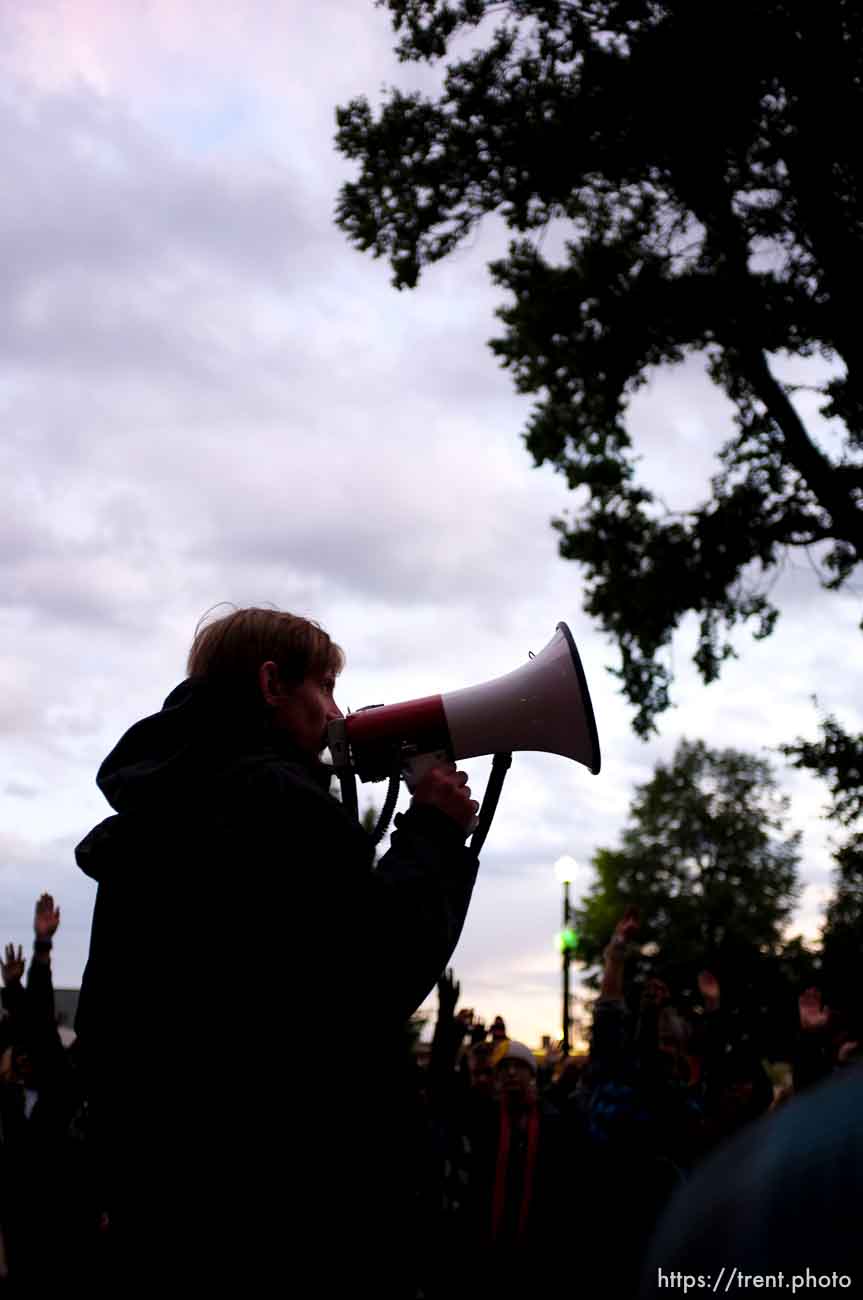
[{"left": 0, "top": 0, "right": 863, "bottom": 1043}]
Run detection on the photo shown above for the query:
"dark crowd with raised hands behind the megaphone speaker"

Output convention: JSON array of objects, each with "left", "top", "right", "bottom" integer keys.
[{"left": 0, "top": 894, "right": 860, "bottom": 1300}]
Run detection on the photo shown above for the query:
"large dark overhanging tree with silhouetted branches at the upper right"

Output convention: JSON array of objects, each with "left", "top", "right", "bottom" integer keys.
[{"left": 337, "top": 0, "right": 863, "bottom": 736}]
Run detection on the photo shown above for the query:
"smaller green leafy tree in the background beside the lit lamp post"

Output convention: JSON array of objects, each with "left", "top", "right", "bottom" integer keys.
[{"left": 574, "top": 741, "right": 799, "bottom": 979}]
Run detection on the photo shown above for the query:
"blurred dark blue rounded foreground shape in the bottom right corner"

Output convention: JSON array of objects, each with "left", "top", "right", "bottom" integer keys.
[{"left": 641, "top": 1065, "right": 863, "bottom": 1300}]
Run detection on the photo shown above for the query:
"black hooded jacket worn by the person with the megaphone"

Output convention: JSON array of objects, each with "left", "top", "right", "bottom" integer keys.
[{"left": 75, "top": 679, "right": 477, "bottom": 1289}]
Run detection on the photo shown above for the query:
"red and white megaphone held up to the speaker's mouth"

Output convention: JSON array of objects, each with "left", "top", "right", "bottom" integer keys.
[{"left": 328, "top": 623, "right": 600, "bottom": 849}]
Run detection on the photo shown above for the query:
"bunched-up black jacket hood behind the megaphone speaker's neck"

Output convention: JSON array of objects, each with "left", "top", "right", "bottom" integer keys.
[{"left": 75, "top": 677, "right": 330, "bottom": 880}]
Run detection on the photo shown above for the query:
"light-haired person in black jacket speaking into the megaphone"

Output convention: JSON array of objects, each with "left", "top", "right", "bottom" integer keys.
[{"left": 77, "top": 608, "right": 478, "bottom": 1294}]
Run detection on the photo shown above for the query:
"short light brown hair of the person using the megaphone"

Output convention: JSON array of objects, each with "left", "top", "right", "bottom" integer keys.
[{"left": 186, "top": 606, "right": 344, "bottom": 686}]
